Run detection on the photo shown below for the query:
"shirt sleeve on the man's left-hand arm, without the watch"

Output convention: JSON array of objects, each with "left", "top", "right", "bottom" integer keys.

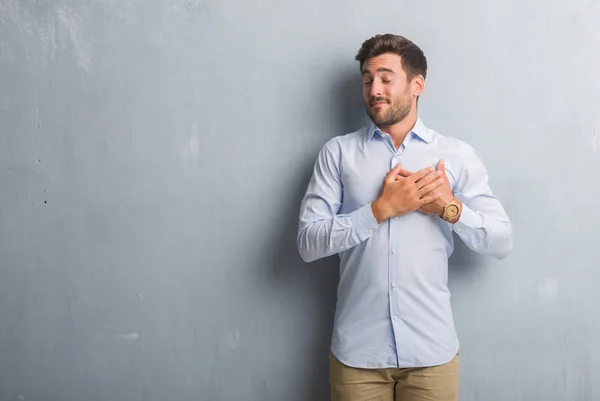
[{"left": 297, "top": 138, "right": 380, "bottom": 262}]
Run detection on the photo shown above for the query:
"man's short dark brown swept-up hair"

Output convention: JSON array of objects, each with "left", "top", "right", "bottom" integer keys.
[{"left": 356, "top": 33, "right": 427, "bottom": 81}]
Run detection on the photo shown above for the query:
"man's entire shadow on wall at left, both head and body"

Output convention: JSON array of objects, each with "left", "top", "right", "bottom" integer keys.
[{"left": 269, "top": 68, "right": 366, "bottom": 401}]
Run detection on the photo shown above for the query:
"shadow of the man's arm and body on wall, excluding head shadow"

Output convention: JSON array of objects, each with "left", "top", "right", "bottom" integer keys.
[{"left": 270, "top": 161, "right": 339, "bottom": 401}]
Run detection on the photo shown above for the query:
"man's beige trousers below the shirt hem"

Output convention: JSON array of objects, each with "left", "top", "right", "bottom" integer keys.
[{"left": 329, "top": 351, "right": 460, "bottom": 401}]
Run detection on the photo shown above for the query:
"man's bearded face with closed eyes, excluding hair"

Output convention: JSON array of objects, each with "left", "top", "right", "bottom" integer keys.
[{"left": 362, "top": 53, "right": 416, "bottom": 127}]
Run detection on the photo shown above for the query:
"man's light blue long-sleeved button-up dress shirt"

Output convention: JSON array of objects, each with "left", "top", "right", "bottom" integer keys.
[{"left": 297, "top": 119, "right": 513, "bottom": 368}]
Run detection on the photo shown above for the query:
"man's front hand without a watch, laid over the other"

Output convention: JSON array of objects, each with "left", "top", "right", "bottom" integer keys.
[{"left": 371, "top": 163, "right": 444, "bottom": 224}]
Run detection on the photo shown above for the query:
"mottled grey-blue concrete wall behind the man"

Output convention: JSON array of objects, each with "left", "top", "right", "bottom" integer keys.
[{"left": 0, "top": 0, "right": 600, "bottom": 401}]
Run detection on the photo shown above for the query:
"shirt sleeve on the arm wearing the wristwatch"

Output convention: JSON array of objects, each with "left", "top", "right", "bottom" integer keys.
[{"left": 451, "top": 145, "right": 513, "bottom": 259}]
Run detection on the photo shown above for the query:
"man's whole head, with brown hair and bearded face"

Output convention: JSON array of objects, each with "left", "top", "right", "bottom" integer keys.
[{"left": 356, "top": 34, "right": 427, "bottom": 127}]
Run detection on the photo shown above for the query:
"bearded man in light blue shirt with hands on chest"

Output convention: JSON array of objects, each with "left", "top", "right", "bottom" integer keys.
[{"left": 298, "top": 34, "right": 513, "bottom": 401}]
